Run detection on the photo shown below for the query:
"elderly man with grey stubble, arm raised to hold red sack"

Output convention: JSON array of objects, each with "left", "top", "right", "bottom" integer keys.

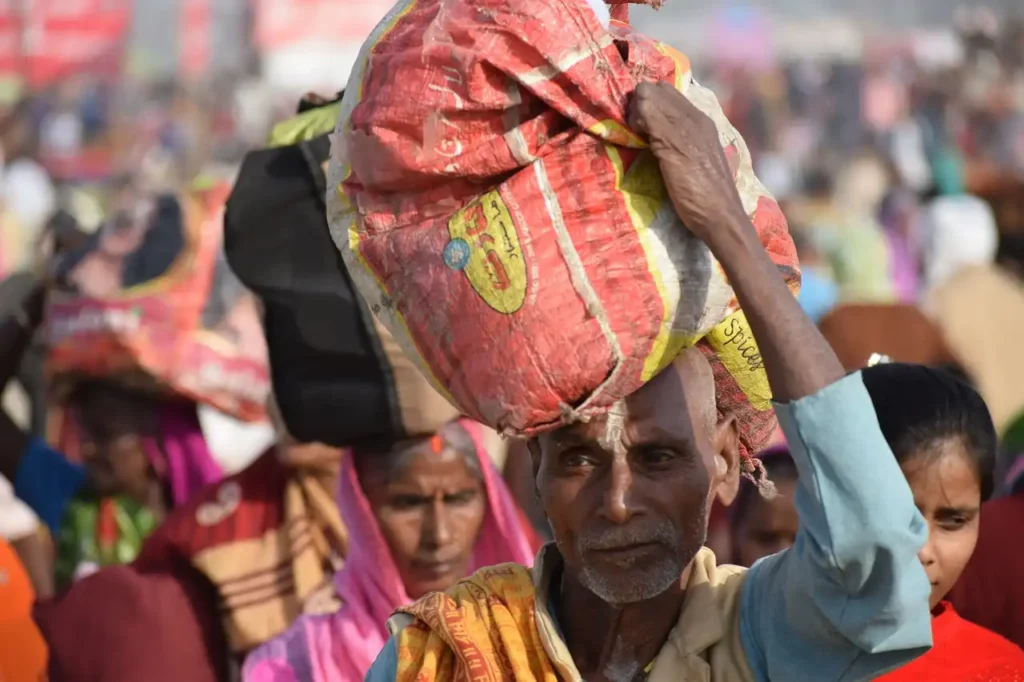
[{"left": 367, "top": 85, "right": 931, "bottom": 682}]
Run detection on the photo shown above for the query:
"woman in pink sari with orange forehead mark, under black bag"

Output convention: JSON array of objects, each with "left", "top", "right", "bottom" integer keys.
[{"left": 242, "top": 413, "right": 540, "bottom": 682}]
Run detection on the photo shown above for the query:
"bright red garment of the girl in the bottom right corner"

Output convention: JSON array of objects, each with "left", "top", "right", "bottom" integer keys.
[{"left": 879, "top": 602, "right": 1024, "bottom": 682}]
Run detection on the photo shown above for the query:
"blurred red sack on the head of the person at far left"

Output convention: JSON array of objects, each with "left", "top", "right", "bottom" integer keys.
[{"left": 45, "top": 186, "right": 269, "bottom": 421}]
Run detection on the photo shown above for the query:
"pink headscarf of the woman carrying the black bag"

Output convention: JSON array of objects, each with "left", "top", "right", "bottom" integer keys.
[{"left": 242, "top": 420, "right": 540, "bottom": 682}]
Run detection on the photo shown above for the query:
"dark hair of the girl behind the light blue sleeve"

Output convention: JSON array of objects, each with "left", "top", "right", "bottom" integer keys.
[{"left": 861, "top": 363, "right": 998, "bottom": 500}]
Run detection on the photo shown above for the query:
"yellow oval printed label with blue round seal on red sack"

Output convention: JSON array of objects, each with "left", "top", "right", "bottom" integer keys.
[{"left": 443, "top": 187, "right": 526, "bottom": 314}]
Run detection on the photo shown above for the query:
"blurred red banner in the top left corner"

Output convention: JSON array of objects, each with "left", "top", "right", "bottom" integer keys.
[{"left": 0, "top": 0, "right": 132, "bottom": 87}]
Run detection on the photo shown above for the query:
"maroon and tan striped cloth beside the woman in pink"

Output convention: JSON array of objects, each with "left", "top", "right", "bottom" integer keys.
[{"left": 134, "top": 446, "right": 348, "bottom": 658}]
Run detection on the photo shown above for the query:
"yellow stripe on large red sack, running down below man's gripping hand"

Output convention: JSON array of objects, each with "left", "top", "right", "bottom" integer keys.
[{"left": 604, "top": 144, "right": 692, "bottom": 381}]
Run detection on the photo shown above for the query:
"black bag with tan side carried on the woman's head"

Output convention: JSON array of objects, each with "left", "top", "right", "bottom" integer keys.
[{"left": 224, "top": 122, "right": 458, "bottom": 446}]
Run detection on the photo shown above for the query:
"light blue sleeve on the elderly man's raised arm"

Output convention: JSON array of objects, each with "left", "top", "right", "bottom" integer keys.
[{"left": 740, "top": 373, "right": 932, "bottom": 682}]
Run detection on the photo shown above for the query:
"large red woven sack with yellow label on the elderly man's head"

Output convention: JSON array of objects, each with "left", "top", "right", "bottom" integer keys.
[{"left": 328, "top": 0, "right": 799, "bottom": 451}]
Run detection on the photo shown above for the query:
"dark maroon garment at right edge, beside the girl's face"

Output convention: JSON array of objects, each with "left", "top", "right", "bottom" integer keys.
[{"left": 949, "top": 495, "right": 1024, "bottom": 647}]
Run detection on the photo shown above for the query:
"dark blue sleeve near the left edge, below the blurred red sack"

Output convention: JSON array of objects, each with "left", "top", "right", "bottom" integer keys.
[{"left": 13, "top": 438, "right": 85, "bottom": 538}]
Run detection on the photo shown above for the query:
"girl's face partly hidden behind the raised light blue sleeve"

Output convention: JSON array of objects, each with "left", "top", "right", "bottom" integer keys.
[{"left": 902, "top": 438, "right": 981, "bottom": 608}]
